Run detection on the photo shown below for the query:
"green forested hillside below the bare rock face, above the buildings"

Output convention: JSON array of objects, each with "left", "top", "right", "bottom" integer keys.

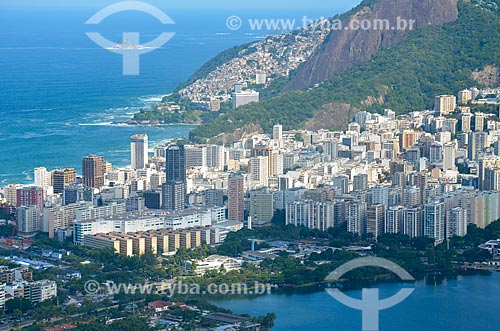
[{"left": 191, "top": 3, "right": 500, "bottom": 141}]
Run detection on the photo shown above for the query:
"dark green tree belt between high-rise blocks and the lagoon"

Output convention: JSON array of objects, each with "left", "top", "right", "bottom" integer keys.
[{"left": 173, "top": 217, "right": 500, "bottom": 288}]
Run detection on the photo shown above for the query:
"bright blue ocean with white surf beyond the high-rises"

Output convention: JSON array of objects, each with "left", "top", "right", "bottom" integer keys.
[{"left": 0, "top": 2, "right": 338, "bottom": 186}]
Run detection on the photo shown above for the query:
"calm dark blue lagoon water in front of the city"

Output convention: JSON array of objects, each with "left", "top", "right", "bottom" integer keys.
[{"left": 212, "top": 273, "right": 500, "bottom": 331}]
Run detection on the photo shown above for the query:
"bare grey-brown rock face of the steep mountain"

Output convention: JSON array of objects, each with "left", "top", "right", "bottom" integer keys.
[{"left": 288, "top": 0, "right": 458, "bottom": 90}]
